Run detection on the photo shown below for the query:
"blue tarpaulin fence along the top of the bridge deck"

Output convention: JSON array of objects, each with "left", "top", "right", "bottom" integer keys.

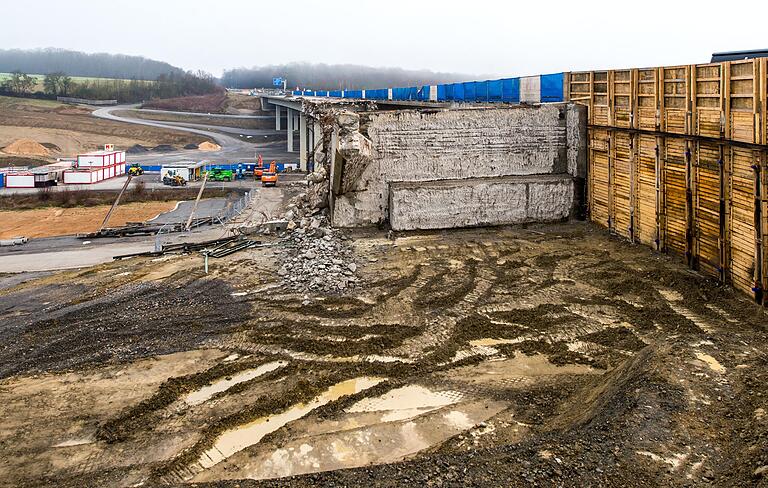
[{"left": 293, "top": 73, "right": 565, "bottom": 103}]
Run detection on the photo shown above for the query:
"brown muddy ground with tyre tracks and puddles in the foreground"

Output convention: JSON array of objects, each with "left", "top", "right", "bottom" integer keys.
[{"left": 0, "top": 223, "right": 768, "bottom": 486}]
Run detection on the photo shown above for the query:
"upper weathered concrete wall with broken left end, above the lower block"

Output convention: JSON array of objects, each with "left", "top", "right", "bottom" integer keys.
[{"left": 332, "top": 104, "right": 586, "bottom": 227}]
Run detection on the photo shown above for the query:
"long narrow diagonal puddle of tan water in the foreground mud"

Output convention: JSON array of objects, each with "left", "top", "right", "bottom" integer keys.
[{"left": 198, "top": 377, "right": 384, "bottom": 469}]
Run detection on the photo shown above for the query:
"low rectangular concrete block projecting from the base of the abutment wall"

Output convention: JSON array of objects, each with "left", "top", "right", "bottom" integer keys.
[{"left": 389, "top": 175, "right": 573, "bottom": 230}]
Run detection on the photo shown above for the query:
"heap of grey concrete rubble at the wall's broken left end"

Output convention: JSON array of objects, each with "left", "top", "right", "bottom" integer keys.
[{"left": 277, "top": 216, "right": 358, "bottom": 293}]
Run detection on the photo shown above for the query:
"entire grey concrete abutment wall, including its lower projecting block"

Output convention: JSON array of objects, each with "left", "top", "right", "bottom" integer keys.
[{"left": 320, "top": 104, "right": 586, "bottom": 230}]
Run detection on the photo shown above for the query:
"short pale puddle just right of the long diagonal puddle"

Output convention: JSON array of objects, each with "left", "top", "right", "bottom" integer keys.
[{"left": 347, "top": 385, "right": 464, "bottom": 422}]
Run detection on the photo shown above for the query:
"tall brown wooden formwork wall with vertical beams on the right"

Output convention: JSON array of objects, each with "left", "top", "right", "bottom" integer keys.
[{"left": 565, "top": 59, "right": 768, "bottom": 302}]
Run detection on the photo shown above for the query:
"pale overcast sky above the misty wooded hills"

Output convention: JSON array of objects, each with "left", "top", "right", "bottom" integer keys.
[{"left": 0, "top": 0, "right": 768, "bottom": 76}]
